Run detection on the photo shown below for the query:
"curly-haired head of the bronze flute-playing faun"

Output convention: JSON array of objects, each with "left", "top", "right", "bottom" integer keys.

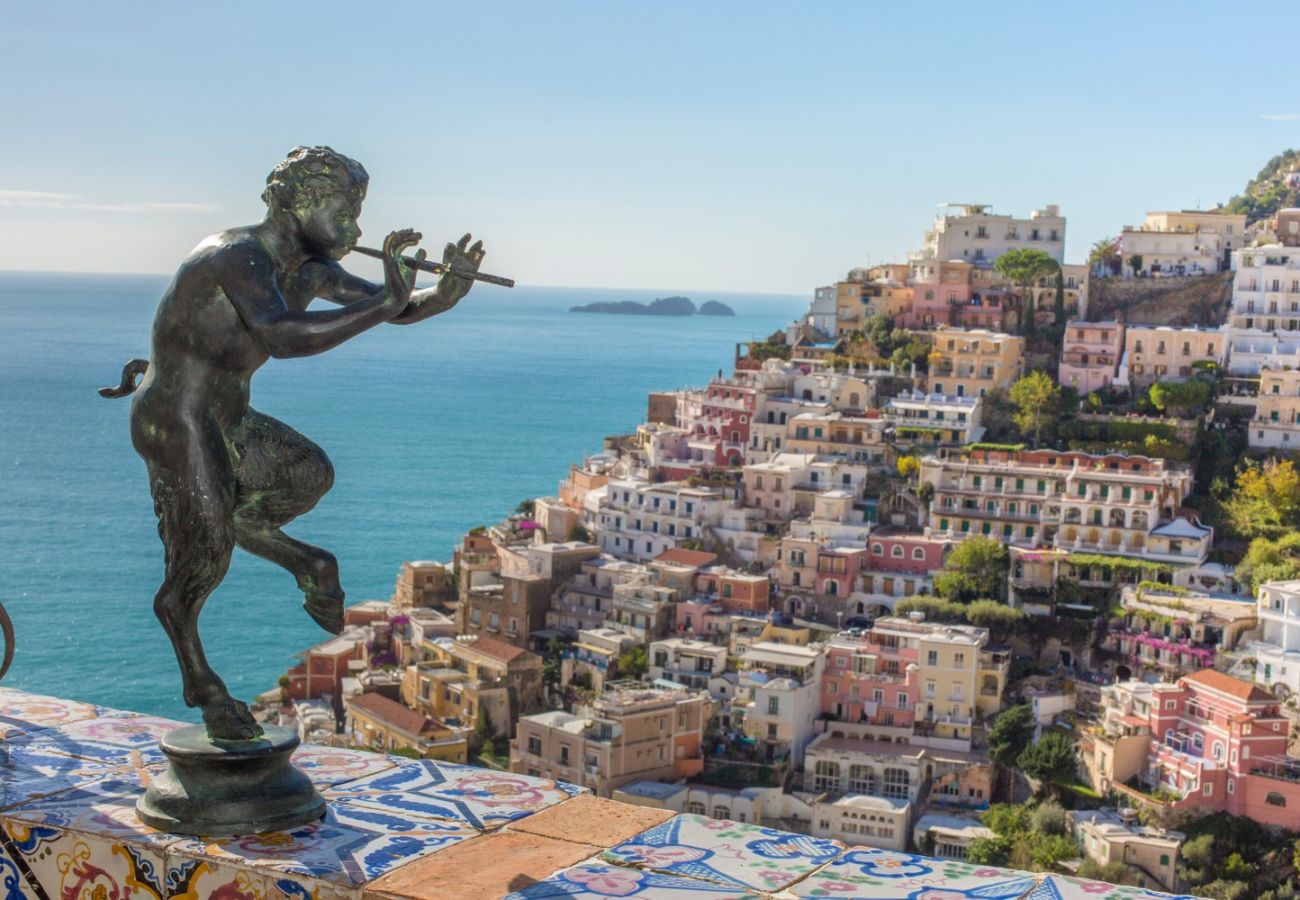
[{"left": 261, "top": 147, "right": 371, "bottom": 259}]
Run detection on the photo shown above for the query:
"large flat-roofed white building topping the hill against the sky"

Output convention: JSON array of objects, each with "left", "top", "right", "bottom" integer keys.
[{"left": 907, "top": 203, "right": 1065, "bottom": 264}]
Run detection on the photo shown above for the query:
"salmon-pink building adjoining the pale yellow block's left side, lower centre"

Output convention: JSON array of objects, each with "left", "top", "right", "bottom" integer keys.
[{"left": 820, "top": 631, "right": 920, "bottom": 728}]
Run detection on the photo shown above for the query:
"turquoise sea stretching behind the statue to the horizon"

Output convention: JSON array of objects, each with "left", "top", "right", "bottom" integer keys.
[{"left": 0, "top": 273, "right": 807, "bottom": 721}]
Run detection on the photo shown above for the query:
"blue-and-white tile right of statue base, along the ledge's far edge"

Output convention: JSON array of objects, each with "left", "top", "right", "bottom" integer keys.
[{"left": 325, "top": 760, "right": 584, "bottom": 830}]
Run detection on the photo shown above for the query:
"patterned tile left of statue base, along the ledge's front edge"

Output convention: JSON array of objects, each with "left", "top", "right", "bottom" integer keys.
[{"left": 5, "top": 779, "right": 179, "bottom": 847}]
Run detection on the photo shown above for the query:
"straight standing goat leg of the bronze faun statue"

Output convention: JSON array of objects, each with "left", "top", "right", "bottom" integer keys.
[{"left": 150, "top": 460, "right": 261, "bottom": 740}]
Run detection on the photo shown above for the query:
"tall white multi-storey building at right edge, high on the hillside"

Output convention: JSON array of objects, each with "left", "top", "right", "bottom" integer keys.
[{"left": 1227, "top": 245, "right": 1300, "bottom": 375}]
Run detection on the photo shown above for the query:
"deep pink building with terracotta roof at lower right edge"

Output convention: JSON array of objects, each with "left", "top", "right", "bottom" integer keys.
[{"left": 1147, "top": 668, "right": 1300, "bottom": 830}]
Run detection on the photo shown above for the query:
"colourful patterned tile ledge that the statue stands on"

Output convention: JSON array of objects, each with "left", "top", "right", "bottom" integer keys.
[{"left": 0, "top": 689, "right": 1196, "bottom": 900}]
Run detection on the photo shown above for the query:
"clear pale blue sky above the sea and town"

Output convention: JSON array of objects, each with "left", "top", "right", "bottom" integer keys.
[{"left": 0, "top": 0, "right": 1300, "bottom": 293}]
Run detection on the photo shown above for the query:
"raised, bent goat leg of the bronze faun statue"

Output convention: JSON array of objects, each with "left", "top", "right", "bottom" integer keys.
[{"left": 234, "top": 410, "right": 343, "bottom": 635}]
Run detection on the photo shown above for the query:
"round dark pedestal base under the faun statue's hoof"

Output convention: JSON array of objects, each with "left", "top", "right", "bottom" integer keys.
[{"left": 135, "top": 726, "right": 325, "bottom": 838}]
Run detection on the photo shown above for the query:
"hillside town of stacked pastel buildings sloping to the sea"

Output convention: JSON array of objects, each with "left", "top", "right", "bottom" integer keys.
[{"left": 263, "top": 158, "right": 1300, "bottom": 899}]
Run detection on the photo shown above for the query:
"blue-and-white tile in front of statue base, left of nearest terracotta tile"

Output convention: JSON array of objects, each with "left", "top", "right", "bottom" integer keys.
[{"left": 170, "top": 804, "right": 478, "bottom": 884}]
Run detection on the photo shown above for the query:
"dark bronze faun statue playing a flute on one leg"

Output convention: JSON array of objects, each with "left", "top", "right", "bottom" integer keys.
[{"left": 100, "top": 147, "right": 488, "bottom": 741}]
